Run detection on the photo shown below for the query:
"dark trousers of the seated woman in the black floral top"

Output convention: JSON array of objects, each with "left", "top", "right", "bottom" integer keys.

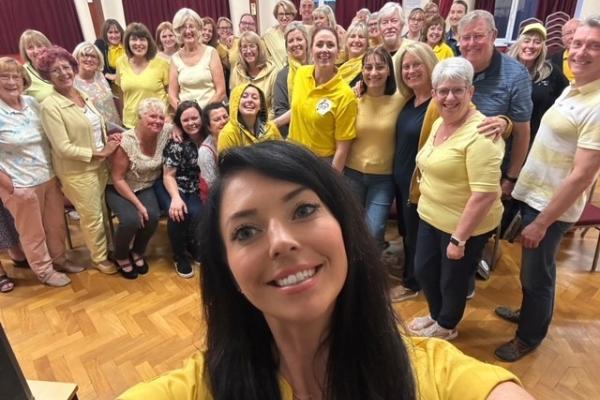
[{"left": 167, "top": 192, "right": 202, "bottom": 261}]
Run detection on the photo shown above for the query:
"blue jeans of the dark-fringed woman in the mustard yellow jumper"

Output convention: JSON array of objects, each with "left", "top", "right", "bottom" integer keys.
[{"left": 344, "top": 168, "right": 394, "bottom": 248}]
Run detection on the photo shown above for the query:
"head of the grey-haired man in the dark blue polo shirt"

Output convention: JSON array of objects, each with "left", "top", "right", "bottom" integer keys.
[{"left": 459, "top": 19, "right": 496, "bottom": 72}]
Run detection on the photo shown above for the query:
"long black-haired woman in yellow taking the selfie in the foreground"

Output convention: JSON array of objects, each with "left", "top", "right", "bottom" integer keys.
[{"left": 117, "top": 141, "right": 532, "bottom": 400}]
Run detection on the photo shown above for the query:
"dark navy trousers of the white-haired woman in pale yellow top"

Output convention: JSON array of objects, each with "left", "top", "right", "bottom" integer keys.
[{"left": 415, "top": 220, "right": 494, "bottom": 329}]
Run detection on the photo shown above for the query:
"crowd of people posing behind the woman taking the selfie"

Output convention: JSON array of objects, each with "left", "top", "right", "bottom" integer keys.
[{"left": 0, "top": 0, "right": 600, "bottom": 378}]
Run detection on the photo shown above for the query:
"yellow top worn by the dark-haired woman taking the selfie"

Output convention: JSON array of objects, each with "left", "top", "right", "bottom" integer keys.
[{"left": 117, "top": 338, "right": 519, "bottom": 400}]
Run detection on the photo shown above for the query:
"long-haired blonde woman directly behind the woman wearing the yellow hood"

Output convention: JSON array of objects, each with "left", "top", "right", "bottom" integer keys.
[{"left": 229, "top": 31, "right": 278, "bottom": 119}]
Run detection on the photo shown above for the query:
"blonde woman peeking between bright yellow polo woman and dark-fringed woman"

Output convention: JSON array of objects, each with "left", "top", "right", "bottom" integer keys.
[{"left": 339, "top": 22, "right": 369, "bottom": 87}]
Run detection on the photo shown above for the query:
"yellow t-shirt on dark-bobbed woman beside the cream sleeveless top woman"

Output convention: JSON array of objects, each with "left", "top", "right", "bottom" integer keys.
[{"left": 116, "top": 57, "right": 169, "bottom": 129}]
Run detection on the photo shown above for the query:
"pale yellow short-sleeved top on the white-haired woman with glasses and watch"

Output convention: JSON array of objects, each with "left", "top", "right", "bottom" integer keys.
[{"left": 417, "top": 111, "right": 504, "bottom": 236}]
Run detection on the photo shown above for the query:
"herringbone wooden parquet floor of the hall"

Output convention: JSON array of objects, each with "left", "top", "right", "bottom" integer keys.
[{"left": 0, "top": 222, "right": 600, "bottom": 400}]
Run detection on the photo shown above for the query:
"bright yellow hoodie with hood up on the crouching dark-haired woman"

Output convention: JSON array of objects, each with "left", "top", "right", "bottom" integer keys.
[{"left": 217, "top": 83, "right": 282, "bottom": 153}]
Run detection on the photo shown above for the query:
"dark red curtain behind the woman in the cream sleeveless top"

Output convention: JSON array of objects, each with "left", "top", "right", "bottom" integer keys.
[{"left": 123, "top": 0, "right": 231, "bottom": 33}]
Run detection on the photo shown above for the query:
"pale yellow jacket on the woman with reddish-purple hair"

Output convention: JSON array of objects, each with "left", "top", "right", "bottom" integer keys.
[{"left": 41, "top": 90, "right": 106, "bottom": 177}]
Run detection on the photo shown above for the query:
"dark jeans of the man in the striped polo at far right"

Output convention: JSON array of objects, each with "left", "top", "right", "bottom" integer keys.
[{"left": 517, "top": 203, "right": 573, "bottom": 347}]
